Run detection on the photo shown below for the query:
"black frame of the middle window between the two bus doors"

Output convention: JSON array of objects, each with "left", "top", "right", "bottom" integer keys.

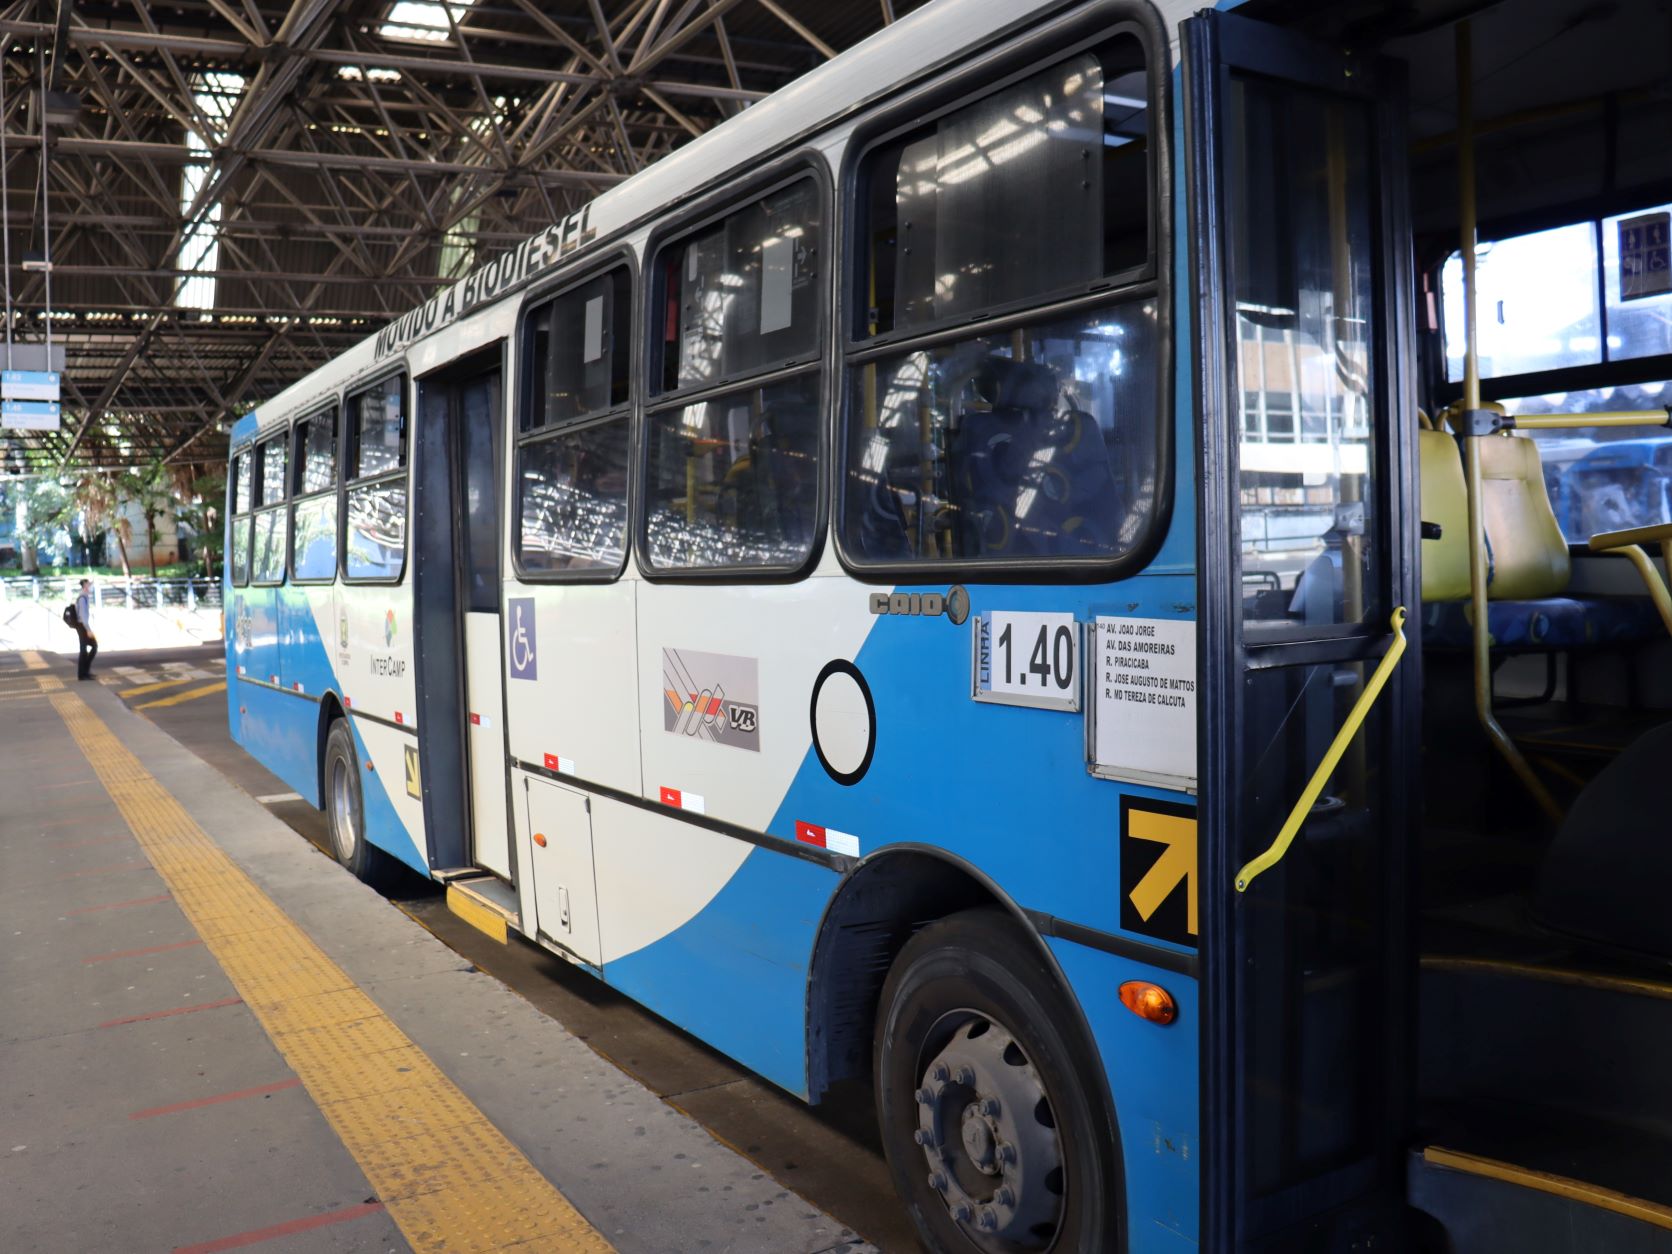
[{"left": 629, "top": 149, "right": 841, "bottom": 584}]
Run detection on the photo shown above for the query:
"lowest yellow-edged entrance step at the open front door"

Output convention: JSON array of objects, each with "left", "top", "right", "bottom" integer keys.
[{"left": 1408, "top": 1145, "right": 1672, "bottom": 1254}]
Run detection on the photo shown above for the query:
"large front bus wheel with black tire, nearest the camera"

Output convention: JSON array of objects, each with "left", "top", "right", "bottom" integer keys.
[{"left": 873, "top": 908, "right": 1125, "bottom": 1254}]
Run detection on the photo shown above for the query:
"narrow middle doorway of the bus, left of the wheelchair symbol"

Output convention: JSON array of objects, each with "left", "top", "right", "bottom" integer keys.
[{"left": 413, "top": 344, "right": 515, "bottom": 879}]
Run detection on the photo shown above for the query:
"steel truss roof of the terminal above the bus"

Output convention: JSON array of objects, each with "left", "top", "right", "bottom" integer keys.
[{"left": 0, "top": 0, "right": 923, "bottom": 472}]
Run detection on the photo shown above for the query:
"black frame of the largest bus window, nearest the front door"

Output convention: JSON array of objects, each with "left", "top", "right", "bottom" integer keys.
[{"left": 826, "top": 8, "right": 1177, "bottom": 584}]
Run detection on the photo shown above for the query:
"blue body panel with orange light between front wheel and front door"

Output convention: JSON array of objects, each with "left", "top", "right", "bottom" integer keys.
[{"left": 1047, "top": 938, "right": 1200, "bottom": 1254}]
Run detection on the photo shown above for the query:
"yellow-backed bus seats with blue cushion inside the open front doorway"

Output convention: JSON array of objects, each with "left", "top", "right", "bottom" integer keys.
[{"left": 1420, "top": 415, "right": 1665, "bottom": 650}]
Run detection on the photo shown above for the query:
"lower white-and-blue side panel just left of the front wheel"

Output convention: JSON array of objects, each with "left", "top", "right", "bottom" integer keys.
[{"left": 594, "top": 815, "right": 838, "bottom": 1097}]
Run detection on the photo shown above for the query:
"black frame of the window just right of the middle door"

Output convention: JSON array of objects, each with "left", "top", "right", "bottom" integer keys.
[{"left": 507, "top": 247, "right": 645, "bottom": 595}]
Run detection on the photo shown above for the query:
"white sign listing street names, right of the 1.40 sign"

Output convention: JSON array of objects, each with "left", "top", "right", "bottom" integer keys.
[{"left": 1087, "top": 617, "right": 1195, "bottom": 793}]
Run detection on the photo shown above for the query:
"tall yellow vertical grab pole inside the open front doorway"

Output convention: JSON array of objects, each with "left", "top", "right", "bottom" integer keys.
[{"left": 1456, "top": 20, "right": 1562, "bottom": 821}]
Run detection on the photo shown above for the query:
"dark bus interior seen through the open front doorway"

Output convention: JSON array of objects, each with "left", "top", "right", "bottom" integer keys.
[{"left": 1244, "top": 0, "right": 1672, "bottom": 1209}]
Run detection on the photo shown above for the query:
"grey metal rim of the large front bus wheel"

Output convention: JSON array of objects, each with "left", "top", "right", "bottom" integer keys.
[{"left": 913, "top": 1010, "right": 1067, "bottom": 1251}]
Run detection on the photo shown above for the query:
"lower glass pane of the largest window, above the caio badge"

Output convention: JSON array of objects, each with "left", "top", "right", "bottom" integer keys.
[{"left": 843, "top": 301, "right": 1157, "bottom": 562}]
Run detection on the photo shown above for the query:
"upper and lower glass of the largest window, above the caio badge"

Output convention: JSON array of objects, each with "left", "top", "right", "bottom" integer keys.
[{"left": 841, "top": 35, "right": 1160, "bottom": 565}]
